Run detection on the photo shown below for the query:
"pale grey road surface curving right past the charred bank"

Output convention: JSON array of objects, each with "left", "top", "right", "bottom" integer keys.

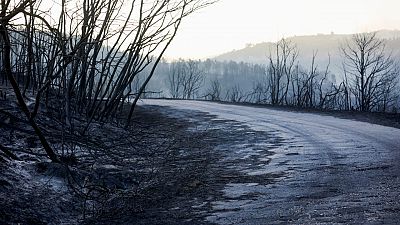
[{"left": 142, "top": 100, "right": 400, "bottom": 224}]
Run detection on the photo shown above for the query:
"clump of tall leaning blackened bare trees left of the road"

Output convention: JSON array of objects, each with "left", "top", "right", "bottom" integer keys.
[{"left": 0, "top": 0, "right": 216, "bottom": 161}]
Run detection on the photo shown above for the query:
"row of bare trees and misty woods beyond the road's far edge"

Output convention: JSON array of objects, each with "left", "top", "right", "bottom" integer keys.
[{"left": 160, "top": 33, "right": 400, "bottom": 113}]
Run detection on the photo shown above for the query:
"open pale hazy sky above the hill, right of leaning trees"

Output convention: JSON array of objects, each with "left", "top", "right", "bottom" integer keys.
[{"left": 166, "top": 0, "right": 400, "bottom": 58}]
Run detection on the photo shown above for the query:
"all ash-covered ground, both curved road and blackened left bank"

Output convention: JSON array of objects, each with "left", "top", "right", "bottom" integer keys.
[{"left": 0, "top": 96, "right": 400, "bottom": 224}]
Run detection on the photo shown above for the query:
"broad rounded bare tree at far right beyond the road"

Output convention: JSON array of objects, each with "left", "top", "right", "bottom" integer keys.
[{"left": 341, "top": 33, "right": 398, "bottom": 111}]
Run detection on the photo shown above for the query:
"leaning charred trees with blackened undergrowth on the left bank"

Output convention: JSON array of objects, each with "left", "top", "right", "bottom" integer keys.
[{"left": 0, "top": 0, "right": 213, "bottom": 224}]
